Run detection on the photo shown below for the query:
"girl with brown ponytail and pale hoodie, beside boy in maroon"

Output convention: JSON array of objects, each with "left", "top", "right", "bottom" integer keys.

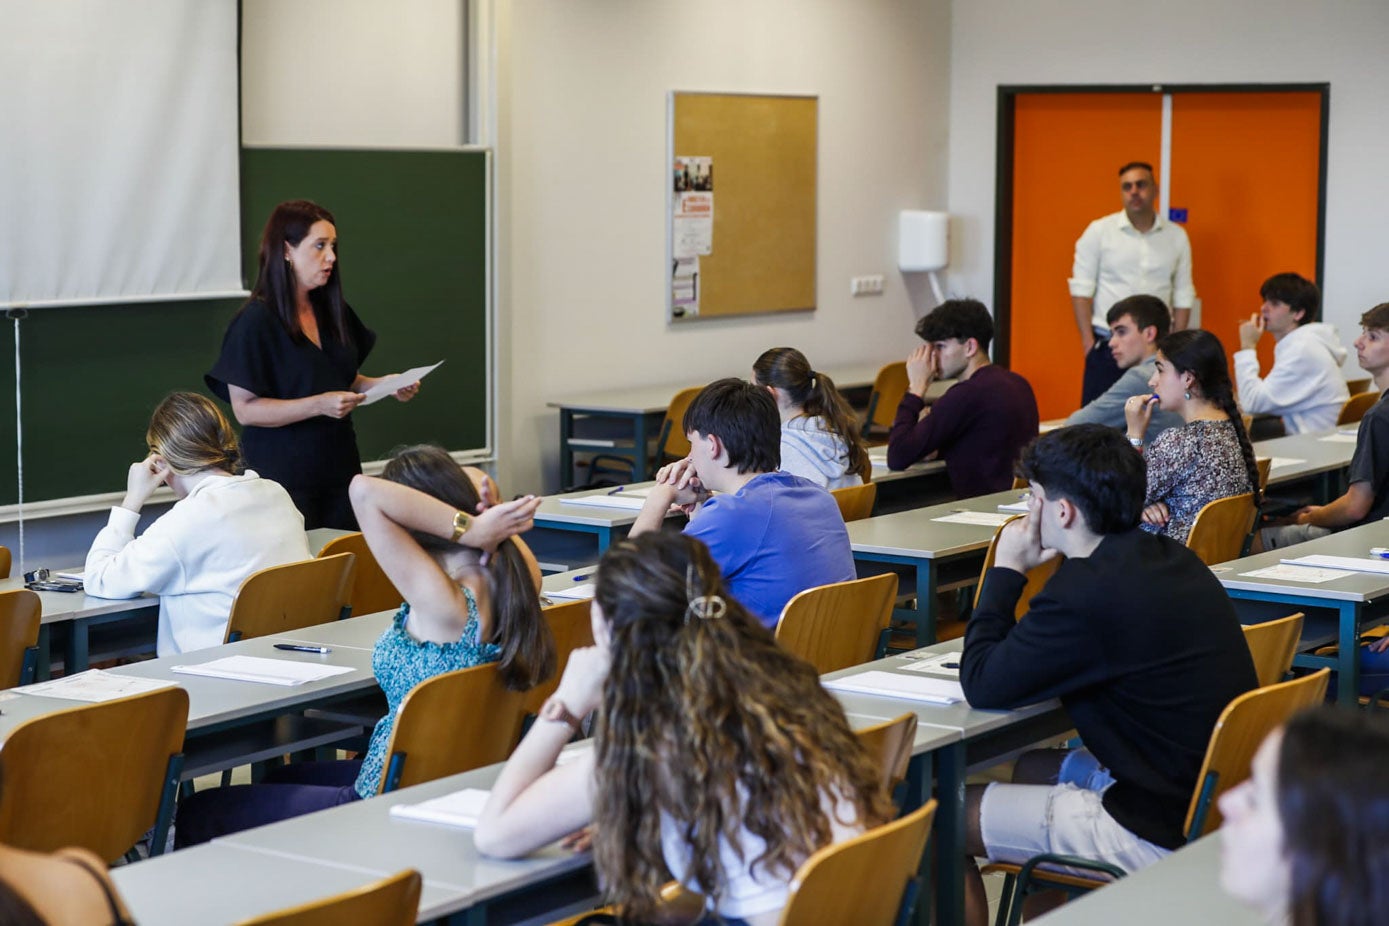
[{"left": 753, "top": 347, "right": 872, "bottom": 489}]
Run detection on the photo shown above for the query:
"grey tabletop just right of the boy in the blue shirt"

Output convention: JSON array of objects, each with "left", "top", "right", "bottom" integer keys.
[{"left": 849, "top": 489, "right": 1025, "bottom": 559}]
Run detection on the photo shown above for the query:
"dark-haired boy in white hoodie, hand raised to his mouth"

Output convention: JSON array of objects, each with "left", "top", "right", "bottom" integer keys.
[{"left": 1235, "top": 273, "right": 1350, "bottom": 435}]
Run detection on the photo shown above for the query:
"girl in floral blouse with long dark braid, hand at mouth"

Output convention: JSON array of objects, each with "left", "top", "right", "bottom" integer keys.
[{"left": 1124, "top": 329, "right": 1260, "bottom": 543}]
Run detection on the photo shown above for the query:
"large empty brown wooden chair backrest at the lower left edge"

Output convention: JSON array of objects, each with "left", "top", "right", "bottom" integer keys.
[{"left": 0, "top": 687, "right": 188, "bottom": 862}]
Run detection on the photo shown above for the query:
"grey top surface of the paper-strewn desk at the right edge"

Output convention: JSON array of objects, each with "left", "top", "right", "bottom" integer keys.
[{"left": 1211, "top": 521, "right": 1389, "bottom": 603}]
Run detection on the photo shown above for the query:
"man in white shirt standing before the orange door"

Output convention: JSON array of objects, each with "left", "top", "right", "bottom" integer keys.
[{"left": 1070, "top": 161, "right": 1196, "bottom": 407}]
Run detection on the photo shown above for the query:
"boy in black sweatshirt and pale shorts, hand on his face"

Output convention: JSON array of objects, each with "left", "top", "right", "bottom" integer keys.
[{"left": 960, "top": 425, "right": 1258, "bottom": 926}]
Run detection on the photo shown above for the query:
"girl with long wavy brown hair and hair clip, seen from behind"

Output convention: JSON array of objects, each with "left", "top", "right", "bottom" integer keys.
[{"left": 475, "top": 532, "right": 892, "bottom": 923}]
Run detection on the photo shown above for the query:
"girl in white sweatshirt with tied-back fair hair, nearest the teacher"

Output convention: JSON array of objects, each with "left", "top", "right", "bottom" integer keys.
[{"left": 82, "top": 393, "right": 311, "bottom": 655}]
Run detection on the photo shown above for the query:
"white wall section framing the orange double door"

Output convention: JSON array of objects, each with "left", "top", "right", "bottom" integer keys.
[{"left": 949, "top": 0, "right": 1389, "bottom": 352}]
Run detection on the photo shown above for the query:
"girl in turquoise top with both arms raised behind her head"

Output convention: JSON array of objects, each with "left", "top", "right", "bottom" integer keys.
[{"left": 174, "top": 444, "right": 556, "bottom": 848}]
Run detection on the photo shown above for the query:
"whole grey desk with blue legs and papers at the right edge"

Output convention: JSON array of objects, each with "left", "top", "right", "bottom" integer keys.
[{"left": 1211, "top": 521, "right": 1389, "bottom": 705}]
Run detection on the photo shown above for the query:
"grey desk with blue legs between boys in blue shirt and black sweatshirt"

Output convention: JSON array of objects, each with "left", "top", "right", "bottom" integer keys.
[{"left": 849, "top": 489, "right": 1022, "bottom": 646}]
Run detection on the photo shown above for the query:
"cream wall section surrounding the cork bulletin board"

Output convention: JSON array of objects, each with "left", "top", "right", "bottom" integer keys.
[{"left": 497, "top": 0, "right": 950, "bottom": 493}]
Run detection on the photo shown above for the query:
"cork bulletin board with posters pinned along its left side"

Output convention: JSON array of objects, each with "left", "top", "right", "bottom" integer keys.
[{"left": 667, "top": 92, "right": 820, "bottom": 322}]
